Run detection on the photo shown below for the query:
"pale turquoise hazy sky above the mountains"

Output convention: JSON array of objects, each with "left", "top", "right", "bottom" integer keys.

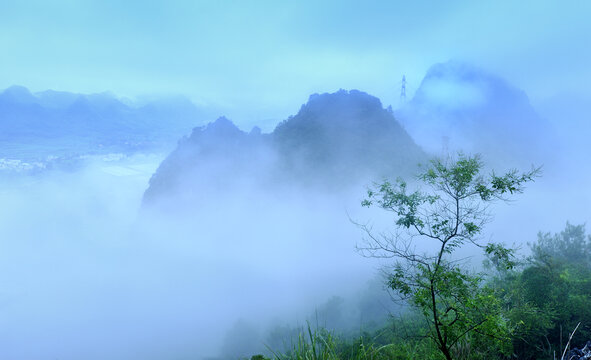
[{"left": 0, "top": 0, "right": 591, "bottom": 122}]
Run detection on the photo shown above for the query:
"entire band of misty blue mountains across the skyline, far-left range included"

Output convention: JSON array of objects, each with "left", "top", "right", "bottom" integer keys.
[{"left": 0, "top": 62, "right": 560, "bottom": 183}]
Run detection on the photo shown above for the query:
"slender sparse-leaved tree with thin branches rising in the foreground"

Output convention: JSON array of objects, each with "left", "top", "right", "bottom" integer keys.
[{"left": 359, "top": 154, "right": 539, "bottom": 359}]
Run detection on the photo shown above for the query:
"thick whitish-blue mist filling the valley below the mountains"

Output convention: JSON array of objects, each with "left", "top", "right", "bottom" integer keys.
[{"left": 0, "top": 155, "right": 400, "bottom": 359}]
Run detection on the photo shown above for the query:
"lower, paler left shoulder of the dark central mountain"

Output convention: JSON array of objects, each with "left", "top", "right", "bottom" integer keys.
[{"left": 144, "top": 117, "right": 272, "bottom": 202}]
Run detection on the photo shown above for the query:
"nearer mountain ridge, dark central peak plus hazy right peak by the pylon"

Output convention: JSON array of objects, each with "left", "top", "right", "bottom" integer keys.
[{"left": 144, "top": 62, "right": 558, "bottom": 208}]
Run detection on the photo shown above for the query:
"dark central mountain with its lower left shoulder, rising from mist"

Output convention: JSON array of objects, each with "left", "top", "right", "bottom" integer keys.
[{"left": 144, "top": 90, "right": 426, "bottom": 202}]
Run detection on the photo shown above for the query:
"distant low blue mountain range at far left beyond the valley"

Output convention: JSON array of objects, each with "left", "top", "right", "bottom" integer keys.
[{"left": 0, "top": 86, "right": 205, "bottom": 156}]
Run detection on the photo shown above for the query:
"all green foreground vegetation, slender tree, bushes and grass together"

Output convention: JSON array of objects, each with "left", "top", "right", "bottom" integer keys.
[{"left": 246, "top": 157, "right": 591, "bottom": 360}]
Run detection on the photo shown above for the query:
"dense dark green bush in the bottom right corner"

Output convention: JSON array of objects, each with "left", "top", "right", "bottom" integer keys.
[{"left": 491, "top": 222, "right": 591, "bottom": 360}]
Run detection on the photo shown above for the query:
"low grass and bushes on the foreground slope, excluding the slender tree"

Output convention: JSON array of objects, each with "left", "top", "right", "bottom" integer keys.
[{"left": 253, "top": 223, "right": 591, "bottom": 360}]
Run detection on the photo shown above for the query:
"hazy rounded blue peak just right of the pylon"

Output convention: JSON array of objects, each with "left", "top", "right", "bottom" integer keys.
[{"left": 396, "top": 61, "right": 558, "bottom": 166}]
